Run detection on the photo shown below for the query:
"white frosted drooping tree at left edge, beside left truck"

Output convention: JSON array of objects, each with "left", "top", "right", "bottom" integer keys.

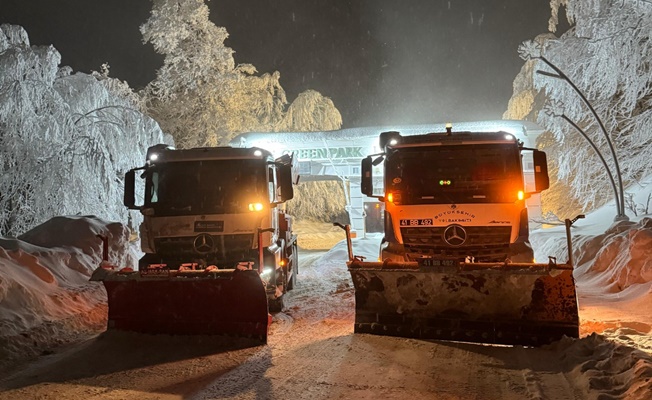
[{"left": 0, "top": 25, "right": 171, "bottom": 236}]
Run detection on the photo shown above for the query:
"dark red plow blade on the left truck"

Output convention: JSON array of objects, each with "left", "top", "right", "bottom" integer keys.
[{"left": 91, "top": 268, "right": 271, "bottom": 343}]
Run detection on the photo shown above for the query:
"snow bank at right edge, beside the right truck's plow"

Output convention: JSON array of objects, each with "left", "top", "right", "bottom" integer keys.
[{"left": 530, "top": 176, "right": 652, "bottom": 304}]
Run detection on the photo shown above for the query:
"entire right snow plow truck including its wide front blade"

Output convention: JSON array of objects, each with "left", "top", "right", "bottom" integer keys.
[{"left": 344, "top": 128, "right": 582, "bottom": 345}]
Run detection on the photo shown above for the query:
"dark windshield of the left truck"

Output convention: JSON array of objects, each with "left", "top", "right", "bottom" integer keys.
[{"left": 145, "top": 160, "right": 269, "bottom": 215}]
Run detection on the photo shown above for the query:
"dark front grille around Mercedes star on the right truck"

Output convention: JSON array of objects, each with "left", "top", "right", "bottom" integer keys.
[{"left": 401, "top": 226, "right": 512, "bottom": 262}]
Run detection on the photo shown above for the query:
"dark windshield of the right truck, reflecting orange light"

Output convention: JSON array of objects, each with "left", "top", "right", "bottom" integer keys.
[{"left": 385, "top": 144, "right": 523, "bottom": 204}]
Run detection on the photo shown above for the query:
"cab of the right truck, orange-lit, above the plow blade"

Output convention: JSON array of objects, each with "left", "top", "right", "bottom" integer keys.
[{"left": 361, "top": 129, "right": 549, "bottom": 266}]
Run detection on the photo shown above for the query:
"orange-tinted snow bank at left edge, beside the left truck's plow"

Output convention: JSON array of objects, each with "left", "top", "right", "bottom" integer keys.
[{"left": 0, "top": 216, "right": 129, "bottom": 368}]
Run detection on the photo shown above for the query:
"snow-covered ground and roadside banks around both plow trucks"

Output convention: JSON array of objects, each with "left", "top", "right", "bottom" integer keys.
[{"left": 0, "top": 186, "right": 652, "bottom": 399}]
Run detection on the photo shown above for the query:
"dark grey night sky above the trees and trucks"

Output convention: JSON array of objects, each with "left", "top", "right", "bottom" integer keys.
[{"left": 0, "top": 0, "right": 550, "bottom": 128}]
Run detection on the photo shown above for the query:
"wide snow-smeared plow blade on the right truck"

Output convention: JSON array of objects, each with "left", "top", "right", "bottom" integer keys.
[{"left": 347, "top": 259, "right": 579, "bottom": 346}]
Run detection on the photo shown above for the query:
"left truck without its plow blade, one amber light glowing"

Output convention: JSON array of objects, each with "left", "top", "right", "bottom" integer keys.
[{"left": 125, "top": 144, "right": 298, "bottom": 310}]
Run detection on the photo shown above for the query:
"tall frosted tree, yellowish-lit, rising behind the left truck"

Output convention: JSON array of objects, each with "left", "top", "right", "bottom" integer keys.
[{"left": 141, "top": 0, "right": 342, "bottom": 147}]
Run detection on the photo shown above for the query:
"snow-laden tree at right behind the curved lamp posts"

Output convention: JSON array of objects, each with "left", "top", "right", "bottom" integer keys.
[{"left": 505, "top": 0, "right": 652, "bottom": 219}]
